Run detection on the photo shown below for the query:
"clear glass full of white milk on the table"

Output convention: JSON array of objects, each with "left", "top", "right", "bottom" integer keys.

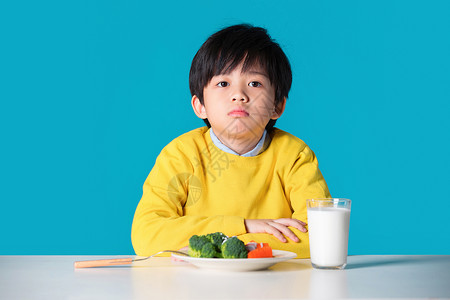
[{"left": 306, "top": 198, "right": 351, "bottom": 270}]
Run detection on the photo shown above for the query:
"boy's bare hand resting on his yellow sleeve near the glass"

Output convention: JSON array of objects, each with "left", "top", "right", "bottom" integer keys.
[{"left": 244, "top": 218, "right": 307, "bottom": 243}]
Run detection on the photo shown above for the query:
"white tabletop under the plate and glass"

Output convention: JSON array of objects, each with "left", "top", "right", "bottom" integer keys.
[{"left": 0, "top": 255, "right": 450, "bottom": 300}]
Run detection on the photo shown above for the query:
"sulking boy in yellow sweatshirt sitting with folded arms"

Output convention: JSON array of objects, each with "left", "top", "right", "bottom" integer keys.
[{"left": 132, "top": 25, "right": 330, "bottom": 258}]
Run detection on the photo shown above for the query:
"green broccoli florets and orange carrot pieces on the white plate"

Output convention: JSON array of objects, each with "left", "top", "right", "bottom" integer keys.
[{"left": 188, "top": 232, "right": 273, "bottom": 258}]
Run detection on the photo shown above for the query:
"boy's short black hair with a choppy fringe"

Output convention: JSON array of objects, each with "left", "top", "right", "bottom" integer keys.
[{"left": 189, "top": 24, "right": 292, "bottom": 130}]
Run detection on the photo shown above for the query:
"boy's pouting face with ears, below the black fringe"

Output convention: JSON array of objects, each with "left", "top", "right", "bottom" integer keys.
[{"left": 192, "top": 63, "right": 285, "bottom": 141}]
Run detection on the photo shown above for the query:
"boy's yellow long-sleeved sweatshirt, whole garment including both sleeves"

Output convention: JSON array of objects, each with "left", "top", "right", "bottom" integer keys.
[{"left": 131, "top": 127, "right": 330, "bottom": 258}]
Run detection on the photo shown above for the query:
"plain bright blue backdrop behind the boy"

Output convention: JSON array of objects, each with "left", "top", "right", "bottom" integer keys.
[{"left": 0, "top": 0, "right": 450, "bottom": 254}]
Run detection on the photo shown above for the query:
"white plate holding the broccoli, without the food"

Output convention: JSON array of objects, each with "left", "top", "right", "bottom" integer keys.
[{"left": 172, "top": 250, "right": 297, "bottom": 271}]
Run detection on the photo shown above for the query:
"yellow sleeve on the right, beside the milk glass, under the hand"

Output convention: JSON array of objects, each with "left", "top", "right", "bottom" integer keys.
[{"left": 239, "top": 146, "right": 331, "bottom": 258}]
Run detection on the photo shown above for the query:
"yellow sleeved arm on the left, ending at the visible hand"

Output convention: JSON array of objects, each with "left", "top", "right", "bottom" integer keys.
[{"left": 131, "top": 145, "right": 245, "bottom": 256}]
